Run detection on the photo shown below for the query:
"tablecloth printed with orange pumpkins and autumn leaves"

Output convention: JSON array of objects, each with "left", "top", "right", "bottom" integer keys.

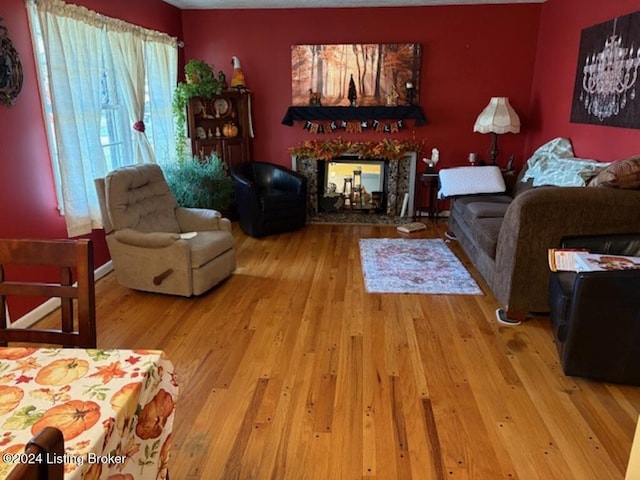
[{"left": 0, "top": 348, "right": 178, "bottom": 480}]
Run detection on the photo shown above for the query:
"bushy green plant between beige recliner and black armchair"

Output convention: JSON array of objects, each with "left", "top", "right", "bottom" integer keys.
[{"left": 163, "top": 152, "right": 233, "bottom": 211}]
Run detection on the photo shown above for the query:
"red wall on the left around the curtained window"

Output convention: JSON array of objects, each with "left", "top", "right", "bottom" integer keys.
[{"left": 0, "top": 0, "right": 182, "bottom": 319}]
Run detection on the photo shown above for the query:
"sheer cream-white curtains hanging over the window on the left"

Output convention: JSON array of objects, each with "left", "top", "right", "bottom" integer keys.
[{"left": 26, "top": 0, "right": 177, "bottom": 237}]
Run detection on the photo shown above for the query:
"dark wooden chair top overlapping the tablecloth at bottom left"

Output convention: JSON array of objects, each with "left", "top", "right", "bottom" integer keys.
[{"left": 7, "top": 427, "right": 64, "bottom": 480}]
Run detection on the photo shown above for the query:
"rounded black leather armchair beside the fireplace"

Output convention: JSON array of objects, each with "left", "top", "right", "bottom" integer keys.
[{"left": 231, "top": 162, "right": 307, "bottom": 237}]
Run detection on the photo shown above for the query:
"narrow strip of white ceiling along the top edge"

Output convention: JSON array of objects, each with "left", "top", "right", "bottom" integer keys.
[{"left": 163, "top": 0, "right": 546, "bottom": 10}]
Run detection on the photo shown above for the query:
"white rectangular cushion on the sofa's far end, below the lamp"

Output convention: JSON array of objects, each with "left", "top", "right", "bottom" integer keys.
[{"left": 438, "top": 165, "right": 506, "bottom": 198}]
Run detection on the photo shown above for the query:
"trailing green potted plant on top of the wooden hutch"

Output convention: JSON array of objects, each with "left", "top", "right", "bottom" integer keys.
[{"left": 172, "top": 59, "right": 226, "bottom": 161}]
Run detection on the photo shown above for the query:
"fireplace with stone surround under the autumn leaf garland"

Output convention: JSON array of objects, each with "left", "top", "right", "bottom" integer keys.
[{"left": 291, "top": 152, "right": 417, "bottom": 216}]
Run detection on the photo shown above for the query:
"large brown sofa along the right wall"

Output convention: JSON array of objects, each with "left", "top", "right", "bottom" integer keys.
[{"left": 449, "top": 170, "right": 640, "bottom": 318}]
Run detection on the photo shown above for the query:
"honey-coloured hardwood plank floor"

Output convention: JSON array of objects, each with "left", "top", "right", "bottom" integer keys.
[{"left": 91, "top": 224, "right": 640, "bottom": 480}]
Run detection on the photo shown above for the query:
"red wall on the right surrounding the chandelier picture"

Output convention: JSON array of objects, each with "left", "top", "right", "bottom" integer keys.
[{"left": 527, "top": 0, "right": 640, "bottom": 161}]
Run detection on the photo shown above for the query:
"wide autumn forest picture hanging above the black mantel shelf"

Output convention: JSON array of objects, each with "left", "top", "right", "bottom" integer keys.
[{"left": 291, "top": 43, "right": 422, "bottom": 106}]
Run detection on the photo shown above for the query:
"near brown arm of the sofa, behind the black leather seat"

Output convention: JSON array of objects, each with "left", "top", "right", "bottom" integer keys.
[{"left": 492, "top": 187, "right": 640, "bottom": 312}]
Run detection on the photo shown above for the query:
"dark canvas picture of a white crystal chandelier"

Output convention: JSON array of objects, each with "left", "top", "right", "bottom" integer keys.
[{"left": 571, "top": 12, "right": 640, "bottom": 128}]
